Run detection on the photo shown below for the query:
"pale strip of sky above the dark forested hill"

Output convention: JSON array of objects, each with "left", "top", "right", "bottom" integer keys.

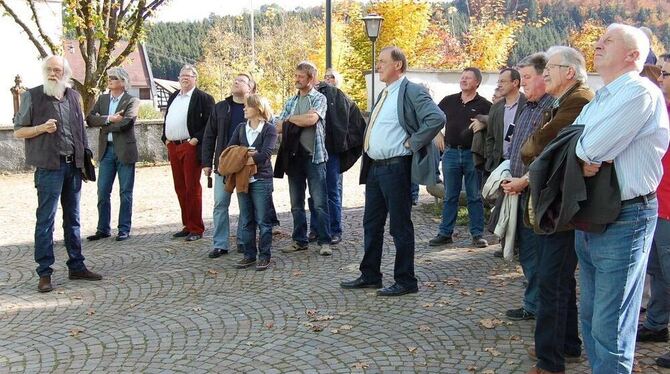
[{"left": 155, "top": 0, "right": 325, "bottom": 22}]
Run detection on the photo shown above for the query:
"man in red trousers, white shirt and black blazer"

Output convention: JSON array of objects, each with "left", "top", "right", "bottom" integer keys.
[{"left": 162, "top": 65, "right": 214, "bottom": 241}]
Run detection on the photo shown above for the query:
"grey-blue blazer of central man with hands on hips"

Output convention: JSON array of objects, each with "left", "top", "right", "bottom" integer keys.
[{"left": 359, "top": 78, "right": 446, "bottom": 185}]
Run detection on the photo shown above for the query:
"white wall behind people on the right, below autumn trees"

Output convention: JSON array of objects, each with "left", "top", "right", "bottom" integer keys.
[{"left": 365, "top": 70, "right": 603, "bottom": 107}]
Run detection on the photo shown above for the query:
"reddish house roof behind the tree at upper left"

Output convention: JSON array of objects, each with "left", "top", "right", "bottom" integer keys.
[{"left": 63, "top": 40, "right": 151, "bottom": 87}]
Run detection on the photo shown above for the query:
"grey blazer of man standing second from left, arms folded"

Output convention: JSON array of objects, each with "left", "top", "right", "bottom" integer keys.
[{"left": 86, "top": 92, "right": 140, "bottom": 164}]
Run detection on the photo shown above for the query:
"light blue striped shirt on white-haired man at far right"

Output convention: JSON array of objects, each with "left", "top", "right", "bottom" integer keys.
[{"left": 574, "top": 71, "right": 670, "bottom": 200}]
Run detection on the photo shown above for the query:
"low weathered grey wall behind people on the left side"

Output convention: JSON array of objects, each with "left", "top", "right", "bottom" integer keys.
[{"left": 0, "top": 120, "right": 167, "bottom": 173}]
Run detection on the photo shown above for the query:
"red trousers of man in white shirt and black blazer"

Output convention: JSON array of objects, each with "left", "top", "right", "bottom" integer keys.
[{"left": 167, "top": 142, "right": 205, "bottom": 235}]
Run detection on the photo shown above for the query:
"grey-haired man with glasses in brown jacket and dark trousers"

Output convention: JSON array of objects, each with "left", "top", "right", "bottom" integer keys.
[{"left": 521, "top": 46, "right": 594, "bottom": 373}]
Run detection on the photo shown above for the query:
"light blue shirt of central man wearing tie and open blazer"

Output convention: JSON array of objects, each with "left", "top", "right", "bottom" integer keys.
[{"left": 367, "top": 76, "right": 412, "bottom": 160}]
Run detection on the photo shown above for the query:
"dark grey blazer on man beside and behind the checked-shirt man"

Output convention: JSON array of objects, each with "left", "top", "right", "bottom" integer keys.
[{"left": 484, "top": 93, "right": 526, "bottom": 173}]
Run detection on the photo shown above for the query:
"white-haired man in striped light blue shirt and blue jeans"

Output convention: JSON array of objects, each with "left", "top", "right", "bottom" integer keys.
[{"left": 575, "top": 24, "right": 670, "bottom": 374}]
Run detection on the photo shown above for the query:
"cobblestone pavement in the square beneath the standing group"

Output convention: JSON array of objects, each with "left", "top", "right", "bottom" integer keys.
[{"left": 0, "top": 166, "right": 668, "bottom": 374}]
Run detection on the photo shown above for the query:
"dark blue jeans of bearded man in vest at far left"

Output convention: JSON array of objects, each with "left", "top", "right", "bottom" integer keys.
[{"left": 35, "top": 161, "right": 86, "bottom": 277}]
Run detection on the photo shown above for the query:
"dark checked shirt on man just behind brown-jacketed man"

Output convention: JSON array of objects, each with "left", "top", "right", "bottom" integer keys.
[{"left": 509, "top": 94, "right": 556, "bottom": 178}]
